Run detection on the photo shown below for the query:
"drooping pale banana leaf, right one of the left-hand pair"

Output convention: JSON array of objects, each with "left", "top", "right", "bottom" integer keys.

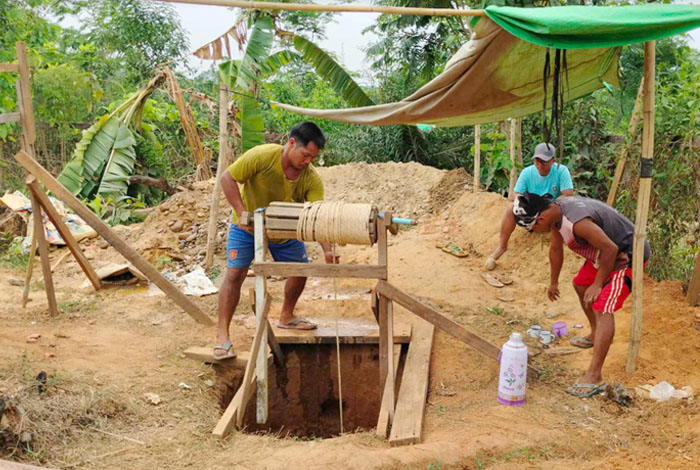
[{"left": 97, "top": 124, "right": 136, "bottom": 198}]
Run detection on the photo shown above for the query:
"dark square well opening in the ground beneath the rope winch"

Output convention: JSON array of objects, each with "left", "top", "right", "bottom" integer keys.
[{"left": 217, "top": 343, "right": 400, "bottom": 438}]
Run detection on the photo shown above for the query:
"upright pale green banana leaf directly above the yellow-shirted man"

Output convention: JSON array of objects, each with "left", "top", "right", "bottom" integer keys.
[{"left": 232, "top": 15, "right": 274, "bottom": 92}]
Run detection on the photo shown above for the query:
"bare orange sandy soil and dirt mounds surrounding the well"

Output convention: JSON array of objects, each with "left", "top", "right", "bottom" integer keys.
[{"left": 0, "top": 164, "right": 700, "bottom": 470}]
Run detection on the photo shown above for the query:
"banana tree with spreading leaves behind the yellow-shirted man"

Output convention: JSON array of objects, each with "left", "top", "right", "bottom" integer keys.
[{"left": 195, "top": 11, "right": 374, "bottom": 152}]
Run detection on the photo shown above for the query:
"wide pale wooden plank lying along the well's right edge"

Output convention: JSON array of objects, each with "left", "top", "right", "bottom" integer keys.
[{"left": 389, "top": 320, "right": 435, "bottom": 446}]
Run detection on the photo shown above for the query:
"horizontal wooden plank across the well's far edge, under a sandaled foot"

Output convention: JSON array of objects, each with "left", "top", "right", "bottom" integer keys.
[{"left": 273, "top": 317, "right": 411, "bottom": 344}]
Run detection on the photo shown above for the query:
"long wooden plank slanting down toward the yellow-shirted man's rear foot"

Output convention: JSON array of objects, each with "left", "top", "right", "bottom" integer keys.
[{"left": 10, "top": 150, "right": 214, "bottom": 326}]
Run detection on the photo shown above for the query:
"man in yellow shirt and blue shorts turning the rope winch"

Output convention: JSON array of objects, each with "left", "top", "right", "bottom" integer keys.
[{"left": 214, "top": 121, "right": 337, "bottom": 359}]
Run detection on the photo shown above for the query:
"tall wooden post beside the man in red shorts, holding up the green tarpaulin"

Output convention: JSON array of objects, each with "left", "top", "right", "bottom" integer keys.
[{"left": 627, "top": 41, "right": 656, "bottom": 372}]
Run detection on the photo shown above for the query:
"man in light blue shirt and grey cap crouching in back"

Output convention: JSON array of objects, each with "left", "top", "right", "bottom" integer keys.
[{"left": 485, "top": 143, "right": 574, "bottom": 271}]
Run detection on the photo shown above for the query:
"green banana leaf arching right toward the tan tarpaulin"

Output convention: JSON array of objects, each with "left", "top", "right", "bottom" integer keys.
[{"left": 293, "top": 35, "right": 374, "bottom": 107}]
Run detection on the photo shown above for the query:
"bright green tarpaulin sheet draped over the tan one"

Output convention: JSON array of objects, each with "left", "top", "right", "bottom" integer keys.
[{"left": 486, "top": 4, "right": 700, "bottom": 49}]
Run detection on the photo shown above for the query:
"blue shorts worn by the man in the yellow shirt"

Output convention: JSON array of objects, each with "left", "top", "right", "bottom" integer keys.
[{"left": 226, "top": 224, "right": 309, "bottom": 269}]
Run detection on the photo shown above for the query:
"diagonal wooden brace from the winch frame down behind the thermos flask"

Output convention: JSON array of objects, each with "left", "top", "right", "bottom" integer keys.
[{"left": 377, "top": 281, "right": 539, "bottom": 377}]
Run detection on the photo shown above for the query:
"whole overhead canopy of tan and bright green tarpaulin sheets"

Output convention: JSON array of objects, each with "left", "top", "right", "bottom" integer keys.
[{"left": 275, "top": 5, "right": 700, "bottom": 126}]
